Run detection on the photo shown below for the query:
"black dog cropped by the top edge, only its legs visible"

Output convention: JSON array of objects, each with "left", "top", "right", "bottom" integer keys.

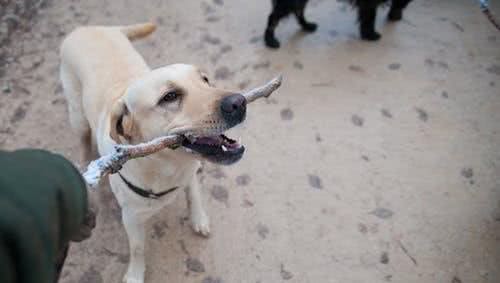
[{"left": 264, "top": 0, "right": 411, "bottom": 48}]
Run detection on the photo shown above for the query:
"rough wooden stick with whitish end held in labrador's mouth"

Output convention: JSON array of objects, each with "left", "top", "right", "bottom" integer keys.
[{"left": 83, "top": 76, "right": 283, "bottom": 188}]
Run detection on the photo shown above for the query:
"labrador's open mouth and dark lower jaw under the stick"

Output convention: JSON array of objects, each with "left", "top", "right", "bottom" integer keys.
[{"left": 182, "top": 135, "right": 245, "bottom": 165}]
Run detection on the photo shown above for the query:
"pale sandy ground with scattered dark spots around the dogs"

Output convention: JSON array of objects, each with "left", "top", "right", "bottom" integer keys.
[{"left": 0, "top": 0, "right": 500, "bottom": 283}]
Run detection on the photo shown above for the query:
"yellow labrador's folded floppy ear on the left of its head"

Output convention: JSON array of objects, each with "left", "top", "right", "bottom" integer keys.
[{"left": 109, "top": 100, "right": 134, "bottom": 143}]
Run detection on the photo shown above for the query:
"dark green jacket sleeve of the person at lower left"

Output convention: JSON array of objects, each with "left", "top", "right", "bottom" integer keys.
[{"left": 0, "top": 150, "right": 87, "bottom": 283}]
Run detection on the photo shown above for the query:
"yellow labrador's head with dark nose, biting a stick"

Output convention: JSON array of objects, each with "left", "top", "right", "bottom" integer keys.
[{"left": 110, "top": 64, "right": 246, "bottom": 164}]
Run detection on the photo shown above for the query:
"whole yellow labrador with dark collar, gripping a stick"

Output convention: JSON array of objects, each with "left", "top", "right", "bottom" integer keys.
[{"left": 60, "top": 23, "right": 246, "bottom": 283}]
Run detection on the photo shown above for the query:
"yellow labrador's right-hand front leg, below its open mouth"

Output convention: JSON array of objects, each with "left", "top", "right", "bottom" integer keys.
[{"left": 187, "top": 175, "right": 210, "bottom": 237}]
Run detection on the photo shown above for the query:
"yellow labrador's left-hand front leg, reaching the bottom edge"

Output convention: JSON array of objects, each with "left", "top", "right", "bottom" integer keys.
[{"left": 122, "top": 212, "right": 146, "bottom": 283}]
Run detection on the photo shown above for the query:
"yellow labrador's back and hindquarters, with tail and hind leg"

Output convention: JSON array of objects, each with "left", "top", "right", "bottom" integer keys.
[{"left": 60, "top": 23, "right": 155, "bottom": 161}]
